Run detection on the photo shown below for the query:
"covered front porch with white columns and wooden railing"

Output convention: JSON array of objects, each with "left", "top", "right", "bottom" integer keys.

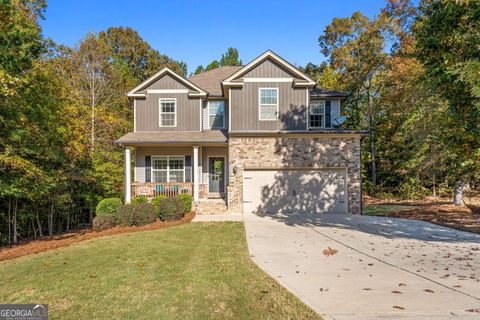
[{"left": 125, "top": 144, "right": 228, "bottom": 203}]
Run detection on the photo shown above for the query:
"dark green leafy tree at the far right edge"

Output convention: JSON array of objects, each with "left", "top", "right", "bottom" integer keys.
[{"left": 414, "top": 0, "right": 480, "bottom": 205}]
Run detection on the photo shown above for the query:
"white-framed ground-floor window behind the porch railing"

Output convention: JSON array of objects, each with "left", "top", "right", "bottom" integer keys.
[{"left": 152, "top": 156, "right": 185, "bottom": 182}]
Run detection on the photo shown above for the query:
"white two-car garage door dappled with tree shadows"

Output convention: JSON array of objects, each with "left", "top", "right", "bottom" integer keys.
[{"left": 243, "top": 169, "right": 348, "bottom": 213}]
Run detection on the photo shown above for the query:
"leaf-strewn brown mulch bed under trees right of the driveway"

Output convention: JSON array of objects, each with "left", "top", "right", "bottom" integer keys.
[{"left": 364, "top": 198, "right": 480, "bottom": 233}]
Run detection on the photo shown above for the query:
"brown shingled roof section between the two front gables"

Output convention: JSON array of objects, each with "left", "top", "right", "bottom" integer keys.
[{"left": 188, "top": 66, "right": 243, "bottom": 97}]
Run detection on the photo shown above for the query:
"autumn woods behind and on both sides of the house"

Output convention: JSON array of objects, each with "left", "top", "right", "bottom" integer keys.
[{"left": 0, "top": 0, "right": 480, "bottom": 244}]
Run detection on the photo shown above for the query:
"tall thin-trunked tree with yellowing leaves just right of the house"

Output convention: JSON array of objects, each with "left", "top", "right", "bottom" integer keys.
[{"left": 318, "top": 12, "right": 388, "bottom": 192}]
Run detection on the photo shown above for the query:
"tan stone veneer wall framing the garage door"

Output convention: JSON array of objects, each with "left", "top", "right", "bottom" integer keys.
[{"left": 227, "top": 135, "right": 361, "bottom": 214}]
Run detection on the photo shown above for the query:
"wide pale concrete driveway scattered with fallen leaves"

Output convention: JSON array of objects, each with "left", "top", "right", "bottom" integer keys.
[{"left": 244, "top": 214, "right": 480, "bottom": 319}]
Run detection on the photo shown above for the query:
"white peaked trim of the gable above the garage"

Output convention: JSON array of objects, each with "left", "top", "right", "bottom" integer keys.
[{"left": 222, "top": 50, "right": 315, "bottom": 86}]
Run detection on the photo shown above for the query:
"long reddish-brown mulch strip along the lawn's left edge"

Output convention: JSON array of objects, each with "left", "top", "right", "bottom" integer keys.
[{"left": 0, "top": 212, "right": 195, "bottom": 261}]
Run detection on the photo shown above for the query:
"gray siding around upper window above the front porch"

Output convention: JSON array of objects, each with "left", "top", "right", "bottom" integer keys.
[{"left": 135, "top": 93, "right": 200, "bottom": 131}]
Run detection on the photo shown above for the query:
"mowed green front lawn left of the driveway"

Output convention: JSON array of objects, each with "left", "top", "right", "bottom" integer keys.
[{"left": 0, "top": 222, "right": 319, "bottom": 319}]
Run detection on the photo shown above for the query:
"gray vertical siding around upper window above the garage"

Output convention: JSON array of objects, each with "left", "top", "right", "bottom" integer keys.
[{"left": 230, "top": 82, "right": 307, "bottom": 131}]
